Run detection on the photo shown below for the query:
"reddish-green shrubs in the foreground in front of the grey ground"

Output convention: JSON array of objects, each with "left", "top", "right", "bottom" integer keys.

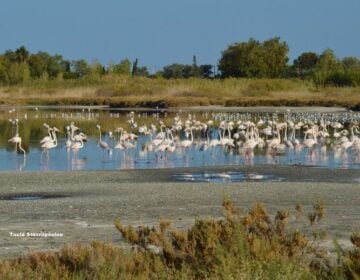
[{"left": 0, "top": 200, "right": 360, "bottom": 279}]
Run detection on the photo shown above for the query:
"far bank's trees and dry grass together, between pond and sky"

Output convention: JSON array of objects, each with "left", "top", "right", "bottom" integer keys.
[{"left": 0, "top": 37, "right": 360, "bottom": 109}]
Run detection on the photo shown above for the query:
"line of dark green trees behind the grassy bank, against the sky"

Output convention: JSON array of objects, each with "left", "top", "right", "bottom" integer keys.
[{"left": 0, "top": 37, "right": 360, "bottom": 86}]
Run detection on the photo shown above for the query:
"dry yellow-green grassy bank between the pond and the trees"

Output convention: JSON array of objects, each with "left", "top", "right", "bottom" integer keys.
[{"left": 0, "top": 75, "right": 360, "bottom": 108}]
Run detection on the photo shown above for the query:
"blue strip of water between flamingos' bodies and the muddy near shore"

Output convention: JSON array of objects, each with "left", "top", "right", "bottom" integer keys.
[{"left": 0, "top": 136, "right": 360, "bottom": 171}]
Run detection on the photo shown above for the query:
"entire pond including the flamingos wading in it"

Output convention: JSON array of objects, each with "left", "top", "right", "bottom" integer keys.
[{"left": 0, "top": 110, "right": 360, "bottom": 171}]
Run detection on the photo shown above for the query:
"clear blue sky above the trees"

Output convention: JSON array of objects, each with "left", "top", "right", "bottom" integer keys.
[{"left": 0, "top": 0, "right": 360, "bottom": 70}]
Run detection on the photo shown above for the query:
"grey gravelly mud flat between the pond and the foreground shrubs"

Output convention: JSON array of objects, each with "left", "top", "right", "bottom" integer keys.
[{"left": 0, "top": 166, "right": 360, "bottom": 258}]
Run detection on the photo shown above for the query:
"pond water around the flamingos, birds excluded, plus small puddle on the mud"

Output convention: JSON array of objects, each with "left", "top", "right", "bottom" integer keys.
[{"left": 0, "top": 106, "right": 360, "bottom": 171}]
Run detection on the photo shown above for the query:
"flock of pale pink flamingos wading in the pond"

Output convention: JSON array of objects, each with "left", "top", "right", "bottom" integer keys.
[{"left": 4, "top": 109, "right": 360, "bottom": 164}]
